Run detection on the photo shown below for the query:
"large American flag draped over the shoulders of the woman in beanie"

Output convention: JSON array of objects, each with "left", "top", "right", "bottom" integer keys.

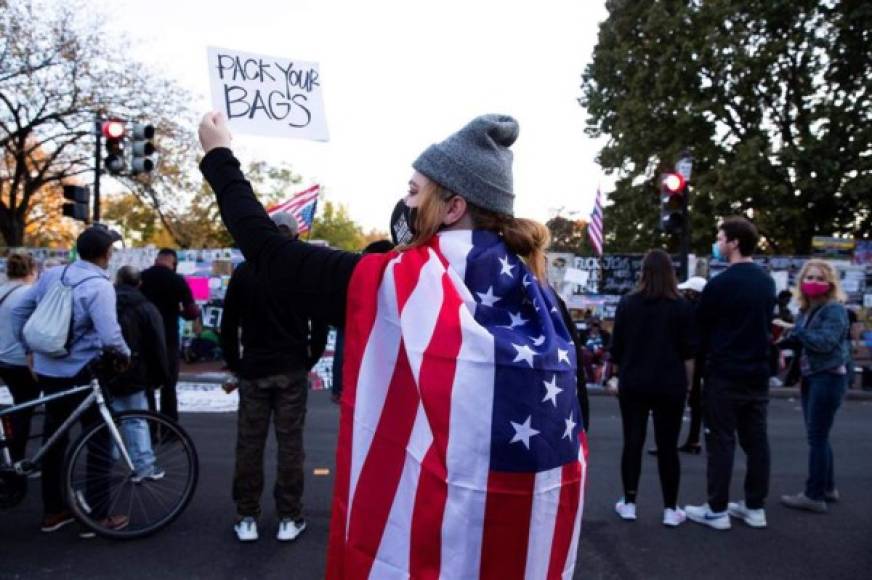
[{"left": 327, "top": 231, "right": 587, "bottom": 580}]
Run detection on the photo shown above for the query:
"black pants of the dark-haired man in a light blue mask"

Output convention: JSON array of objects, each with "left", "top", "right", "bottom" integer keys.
[{"left": 703, "top": 377, "right": 769, "bottom": 512}]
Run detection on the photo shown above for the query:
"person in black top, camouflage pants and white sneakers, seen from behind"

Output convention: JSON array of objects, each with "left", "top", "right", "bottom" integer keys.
[{"left": 221, "top": 213, "right": 327, "bottom": 542}]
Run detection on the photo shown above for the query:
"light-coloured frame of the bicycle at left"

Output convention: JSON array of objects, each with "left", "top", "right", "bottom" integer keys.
[{"left": 0, "top": 379, "right": 133, "bottom": 475}]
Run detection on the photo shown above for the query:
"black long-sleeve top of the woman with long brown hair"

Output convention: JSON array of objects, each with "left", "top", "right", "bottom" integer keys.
[{"left": 611, "top": 293, "right": 698, "bottom": 395}]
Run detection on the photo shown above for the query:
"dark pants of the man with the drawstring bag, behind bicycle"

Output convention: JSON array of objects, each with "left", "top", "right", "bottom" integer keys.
[{"left": 39, "top": 370, "right": 106, "bottom": 514}]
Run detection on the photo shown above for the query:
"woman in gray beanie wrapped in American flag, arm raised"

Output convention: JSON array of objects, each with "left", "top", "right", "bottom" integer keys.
[{"left": 199, "top": 113, "right": 587, "bottom": 580}]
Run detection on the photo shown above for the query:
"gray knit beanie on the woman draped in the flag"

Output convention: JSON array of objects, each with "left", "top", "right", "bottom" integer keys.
[{"left": 412, "top": 115, "right": 519, "bottom": 215}]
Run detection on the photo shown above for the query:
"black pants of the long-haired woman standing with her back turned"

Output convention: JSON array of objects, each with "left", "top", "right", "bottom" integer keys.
[{"left": 619, "top": 391, "right": 684, "bottom": 508}]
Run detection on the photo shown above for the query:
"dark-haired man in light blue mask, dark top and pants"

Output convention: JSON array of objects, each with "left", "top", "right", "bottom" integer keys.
[{"left": 684, "top": 217, "right": 775, "bottom": 530}]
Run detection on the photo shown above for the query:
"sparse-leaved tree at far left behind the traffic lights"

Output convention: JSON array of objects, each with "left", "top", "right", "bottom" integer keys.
[{"left": 0, "top": 0, "right": 196, "bottom": 246}]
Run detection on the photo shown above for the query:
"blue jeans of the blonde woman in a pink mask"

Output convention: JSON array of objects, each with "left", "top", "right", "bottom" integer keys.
[{"left": 802, "top": 371, "right": 848, "bottom": 501}]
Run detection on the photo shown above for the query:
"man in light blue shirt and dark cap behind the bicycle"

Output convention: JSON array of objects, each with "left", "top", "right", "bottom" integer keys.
[{"left": 12, "top": 224, "right": 130, "bottom": 532}]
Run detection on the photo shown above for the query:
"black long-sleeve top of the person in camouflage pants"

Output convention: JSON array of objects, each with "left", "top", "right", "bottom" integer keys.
[{"left": 221, "top": 262, "right": 327, "bottom": 379}]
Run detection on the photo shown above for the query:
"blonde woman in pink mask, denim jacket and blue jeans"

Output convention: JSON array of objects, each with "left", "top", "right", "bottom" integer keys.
[{"left": 776, "top": 260, "right": 850, "bottom": 513}]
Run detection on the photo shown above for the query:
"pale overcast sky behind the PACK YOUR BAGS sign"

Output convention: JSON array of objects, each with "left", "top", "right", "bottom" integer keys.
[{"left": 100, "top": 0, "right": 611, "bottom": 230}]
